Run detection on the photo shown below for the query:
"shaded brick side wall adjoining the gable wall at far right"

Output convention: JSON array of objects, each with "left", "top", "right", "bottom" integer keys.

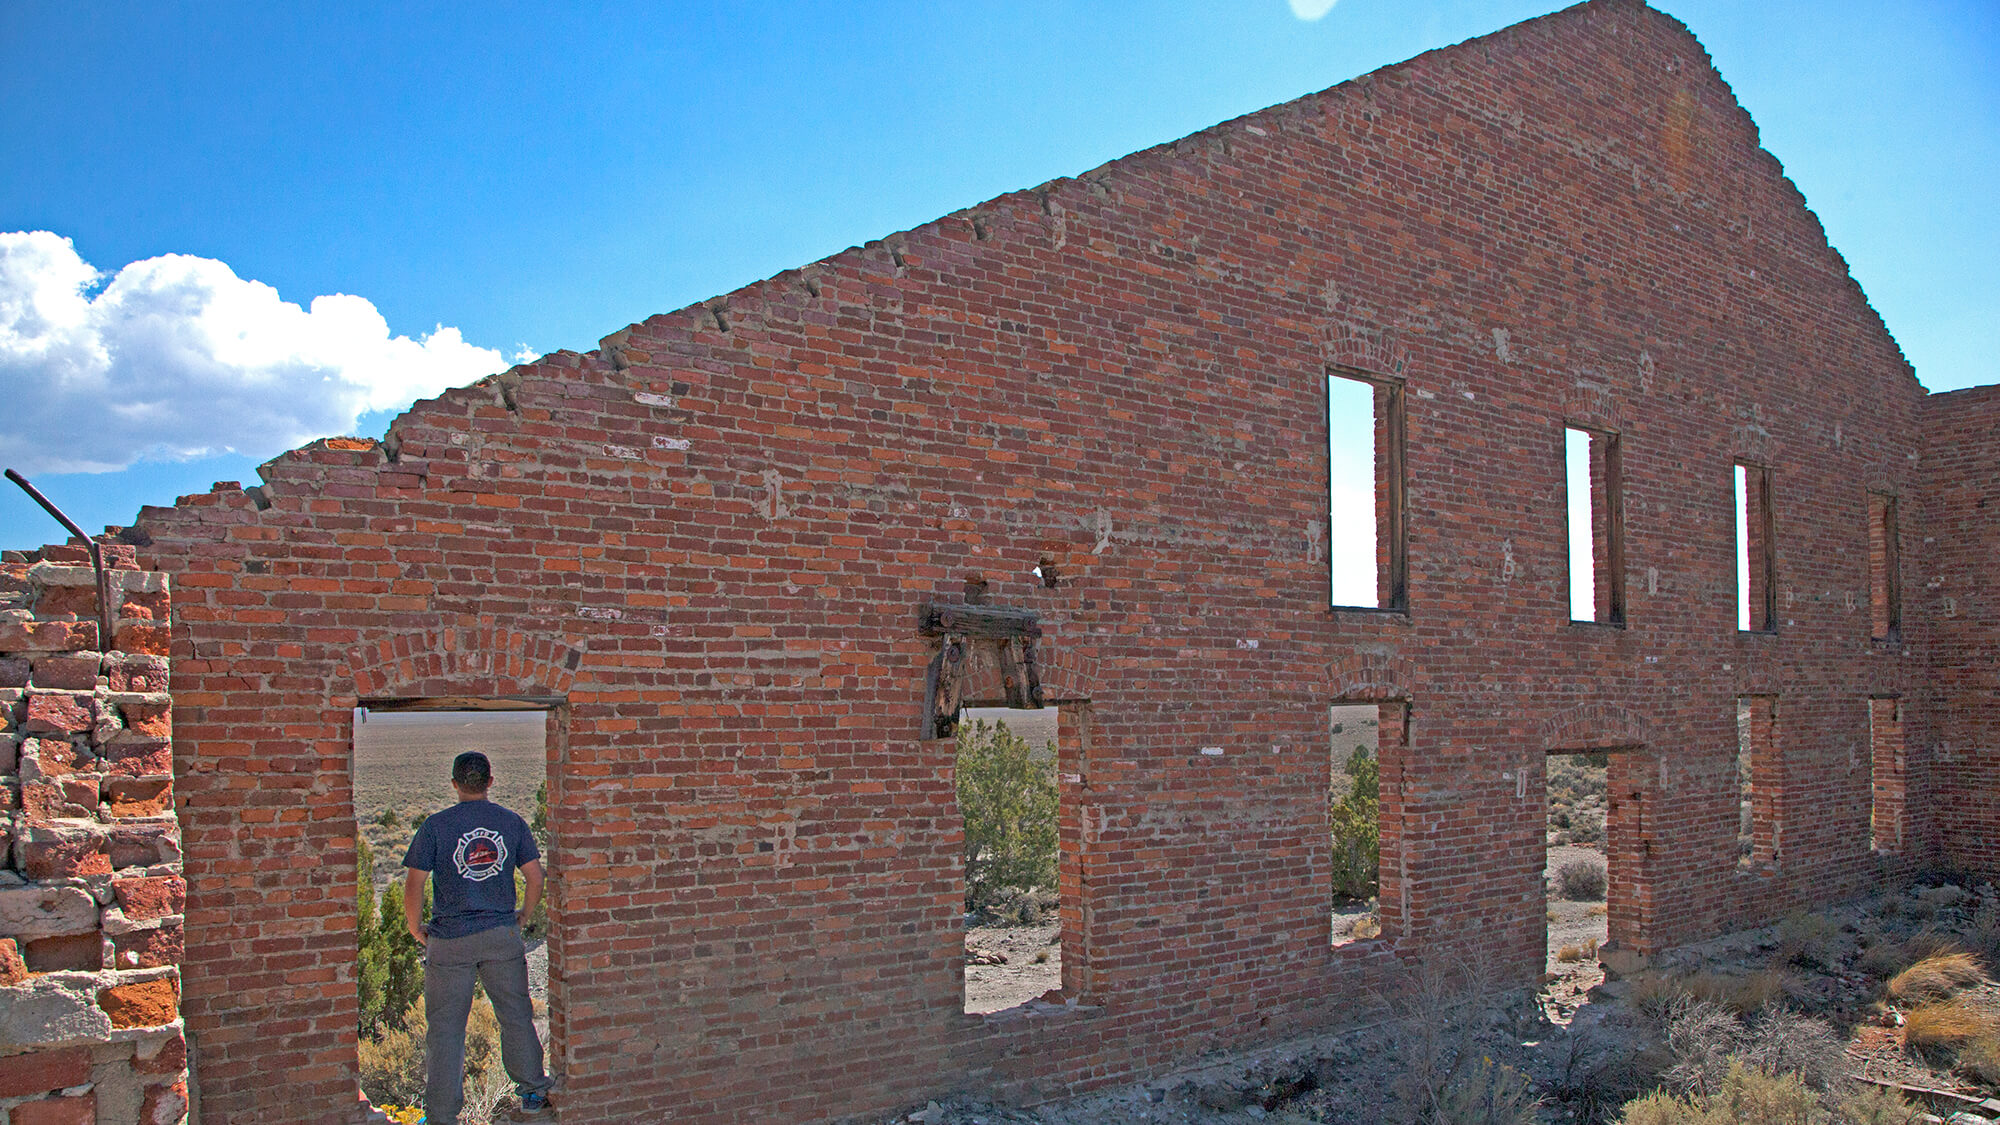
[{"left": 1898, "top": 386, "right": 2000, "bottom": 875}]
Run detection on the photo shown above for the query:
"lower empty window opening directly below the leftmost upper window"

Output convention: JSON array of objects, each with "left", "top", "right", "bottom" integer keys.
[{"left": 1326, "top": 703, "right": 1408, "bottom": 945}]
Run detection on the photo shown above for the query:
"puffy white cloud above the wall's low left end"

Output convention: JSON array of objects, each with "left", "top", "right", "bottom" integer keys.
[{"left": 0, "top": 230, "right": 508, "bottom": 472}]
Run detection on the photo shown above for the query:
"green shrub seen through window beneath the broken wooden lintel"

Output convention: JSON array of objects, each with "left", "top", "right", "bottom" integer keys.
[{"left": 958, "top": 719, "right": 1058, "bottom": 911}]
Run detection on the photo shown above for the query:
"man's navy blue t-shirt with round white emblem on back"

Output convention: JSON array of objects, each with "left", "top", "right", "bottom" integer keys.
[{"left": 402, "top": 799, "right": 542, "bottom": 939}]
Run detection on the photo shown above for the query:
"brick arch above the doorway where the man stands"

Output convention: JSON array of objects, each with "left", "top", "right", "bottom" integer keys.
[{"left": 348, "top": 625, "right": 582, "bottom": 699}]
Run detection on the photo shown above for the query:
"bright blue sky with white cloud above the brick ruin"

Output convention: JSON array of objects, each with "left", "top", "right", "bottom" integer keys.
[{"left": 0, "top": 0, "right": 2000, "bottom": 548}]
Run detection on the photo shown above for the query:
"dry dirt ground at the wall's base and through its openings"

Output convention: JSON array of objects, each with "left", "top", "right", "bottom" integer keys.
[{"left": 916, "top": 849, "right": 2000, "bottom": 1125}]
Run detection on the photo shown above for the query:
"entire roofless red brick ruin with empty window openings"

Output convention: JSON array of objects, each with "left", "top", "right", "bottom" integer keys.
[{"left": 0, "top": 0, "right": 2000, "bottom": 1125}]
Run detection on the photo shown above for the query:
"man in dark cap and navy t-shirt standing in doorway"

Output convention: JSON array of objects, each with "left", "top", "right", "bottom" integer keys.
[{"left": 402, "top": 751, "right": 554, "bottom": 1125}]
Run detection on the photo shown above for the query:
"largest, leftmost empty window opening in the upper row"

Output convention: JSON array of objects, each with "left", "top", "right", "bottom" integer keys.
[{"left": 1326, "top": 372, "right": 1410, "bottom": 611}]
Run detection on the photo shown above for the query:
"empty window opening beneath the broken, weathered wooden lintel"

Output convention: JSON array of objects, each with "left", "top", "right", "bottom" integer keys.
[{"left": 956, "top": 707, "right": 1078, "bottom": 1013}]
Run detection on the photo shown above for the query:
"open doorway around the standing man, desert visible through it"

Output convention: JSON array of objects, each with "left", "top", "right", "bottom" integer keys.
[{"left": 354, "top": 701, "right": 556, "bottom": 1107}]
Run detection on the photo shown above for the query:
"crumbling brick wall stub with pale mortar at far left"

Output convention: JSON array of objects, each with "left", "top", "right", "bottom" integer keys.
[{"left": 0, "top": 544, "right": 188, "bottom": 1125}]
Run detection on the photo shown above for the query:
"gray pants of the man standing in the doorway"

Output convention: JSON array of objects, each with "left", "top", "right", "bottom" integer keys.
[{"left": 424, "top": 925, "right": 554, "bottom": 1125}]
